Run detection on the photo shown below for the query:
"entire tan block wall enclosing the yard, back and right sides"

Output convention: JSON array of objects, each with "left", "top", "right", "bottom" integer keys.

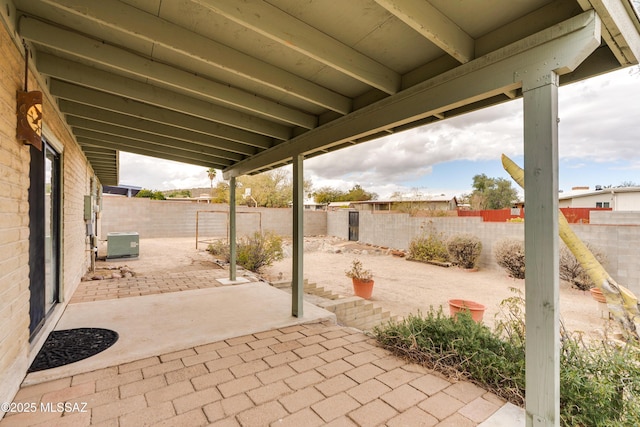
[{"left": 101, "top": 196, "right": 640, "bottom": 295}]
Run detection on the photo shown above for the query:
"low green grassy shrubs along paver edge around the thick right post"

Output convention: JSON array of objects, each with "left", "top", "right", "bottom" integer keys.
[{"left": 374, "top": 290, "right": 640, "bottom": 427}]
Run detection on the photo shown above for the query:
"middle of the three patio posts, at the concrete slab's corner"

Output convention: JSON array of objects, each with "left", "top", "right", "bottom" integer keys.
[{"left": 291, "top": 155, "right": 304, "bottom": 317}]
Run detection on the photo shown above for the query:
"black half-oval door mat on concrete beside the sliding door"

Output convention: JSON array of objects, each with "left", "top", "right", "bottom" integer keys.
[{"left": 27, "top": 328, "right": 118, "bottom": 372}]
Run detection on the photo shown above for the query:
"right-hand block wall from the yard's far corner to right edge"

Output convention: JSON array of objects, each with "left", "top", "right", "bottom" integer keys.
[{"left": 327, "top": 211, "right": 640, "bottom": 295}]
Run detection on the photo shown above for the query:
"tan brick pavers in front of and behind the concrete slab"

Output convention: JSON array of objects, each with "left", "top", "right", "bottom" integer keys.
[{"left": 0, "top": 276, "right": 504, "bottom": 427}]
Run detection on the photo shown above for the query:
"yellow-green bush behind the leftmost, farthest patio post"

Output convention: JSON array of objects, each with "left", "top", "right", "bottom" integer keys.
[{"left": 207, "top": 232, "right": 284, "bottom": 272}]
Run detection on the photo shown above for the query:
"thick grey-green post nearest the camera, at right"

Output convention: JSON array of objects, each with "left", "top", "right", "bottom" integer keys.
[{"left": 523, "top": 71, "right": 560, "bottom": 427}]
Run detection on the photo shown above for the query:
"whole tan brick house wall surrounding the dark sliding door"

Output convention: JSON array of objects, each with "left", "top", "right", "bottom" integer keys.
[{"left": 0, "top": 18, "right": 92, "bottom": 410}]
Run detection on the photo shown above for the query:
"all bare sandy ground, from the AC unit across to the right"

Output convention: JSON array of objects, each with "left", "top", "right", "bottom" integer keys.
[{"left": 98, "top": 237, "right": 606, "bottom": 335}]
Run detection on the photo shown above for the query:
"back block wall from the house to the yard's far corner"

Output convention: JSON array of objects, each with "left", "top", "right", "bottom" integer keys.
[{"left": 100, "top": 195, "right": 327, "bottom": 239}]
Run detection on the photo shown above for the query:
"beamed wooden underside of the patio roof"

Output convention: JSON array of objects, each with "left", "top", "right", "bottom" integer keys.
[{"left": 8, "top": 0, "right": 640, "bottom": 185}]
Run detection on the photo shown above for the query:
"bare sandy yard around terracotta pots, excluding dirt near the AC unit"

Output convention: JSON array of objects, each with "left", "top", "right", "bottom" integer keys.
[{"left": 263, "top": 238, "right": 607, "bottom": 335}]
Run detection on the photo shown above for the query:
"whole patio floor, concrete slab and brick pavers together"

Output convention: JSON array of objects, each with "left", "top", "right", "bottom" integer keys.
[{"left": 0, "top": 239, "right": 524, "bottom": 427}]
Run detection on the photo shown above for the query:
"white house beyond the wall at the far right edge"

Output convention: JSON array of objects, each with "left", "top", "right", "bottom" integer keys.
[{"left": 558, "top": 187, "right": 640, "bottom": 211}]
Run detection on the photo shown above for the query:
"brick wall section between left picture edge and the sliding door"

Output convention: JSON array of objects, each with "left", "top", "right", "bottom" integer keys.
[{"left": 0, "top": 21, "right": 30, "bottom": 415}]
